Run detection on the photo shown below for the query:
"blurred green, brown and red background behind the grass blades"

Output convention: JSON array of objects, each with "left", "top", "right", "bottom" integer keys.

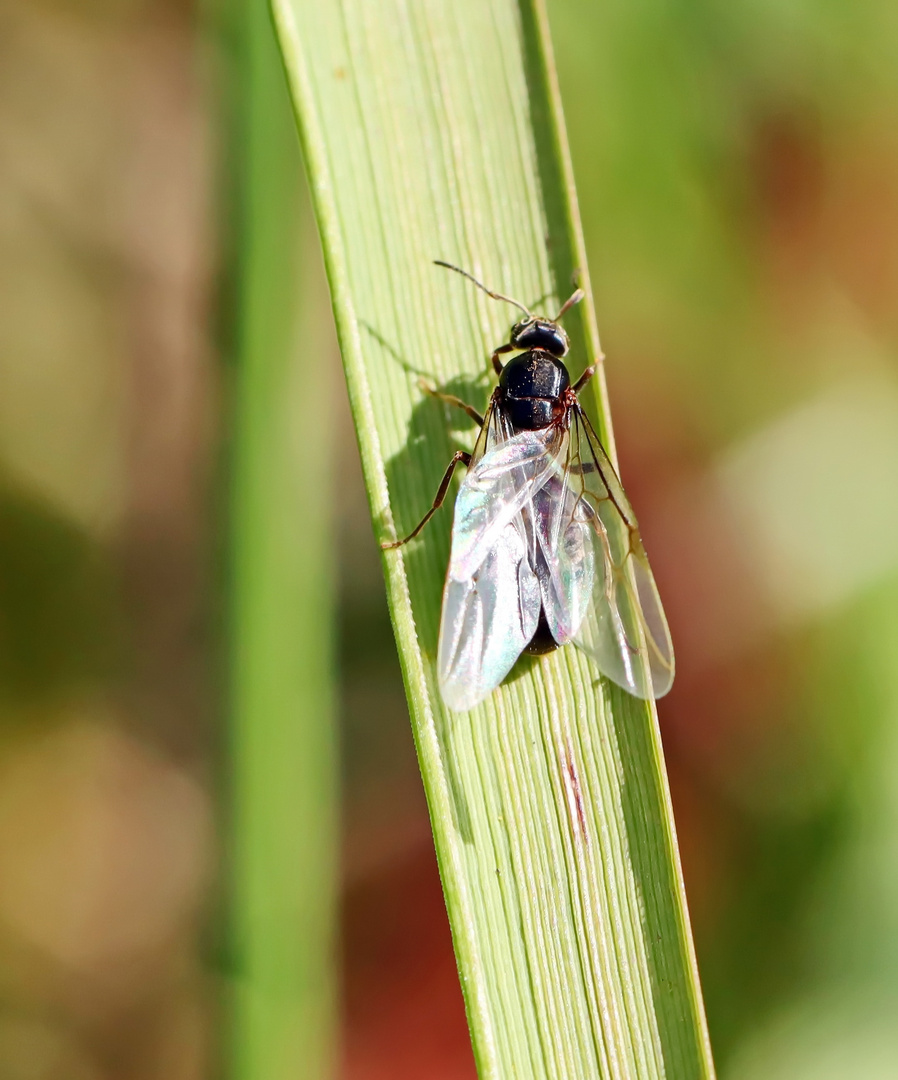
[{"left": 0, "top": 0, "right": 898, "bottom": 1080}]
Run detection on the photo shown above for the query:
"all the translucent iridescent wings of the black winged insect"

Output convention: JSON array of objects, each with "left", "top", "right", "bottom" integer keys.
[{"left": 438, "top": 406, "right": 673, "bottom": 711}]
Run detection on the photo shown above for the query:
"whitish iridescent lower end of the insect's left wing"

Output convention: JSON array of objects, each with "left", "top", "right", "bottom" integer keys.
[{"left": 438, "top": 511, "right": 540, "bottom": 712}]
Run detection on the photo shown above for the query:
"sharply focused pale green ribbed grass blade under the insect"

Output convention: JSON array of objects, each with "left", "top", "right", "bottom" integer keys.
[{"left": 274, "top": 0, "right": 712, "bottom": 1080}]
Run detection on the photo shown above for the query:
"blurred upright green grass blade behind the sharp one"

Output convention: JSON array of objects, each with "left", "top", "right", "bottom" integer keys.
[{"left": 227, "top": 3, "right": 338, "bottom": 1080}]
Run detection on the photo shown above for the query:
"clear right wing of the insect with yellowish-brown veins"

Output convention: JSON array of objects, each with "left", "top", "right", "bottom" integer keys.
[{"left": 561, "top": 408, "right": 674, "bottom": 698}]
